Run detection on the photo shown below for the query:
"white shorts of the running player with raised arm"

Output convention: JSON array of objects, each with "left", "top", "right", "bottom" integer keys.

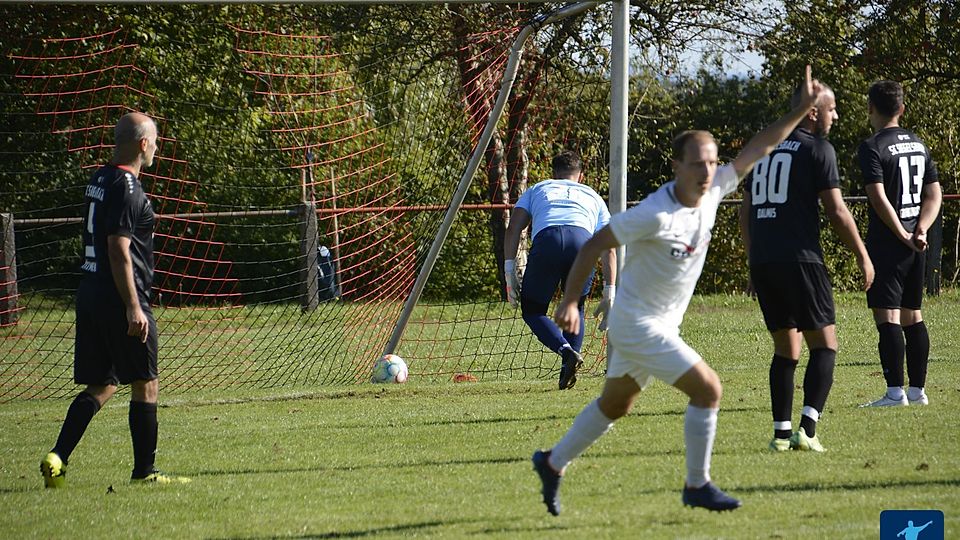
[{"left": 607, "top": 318, "right": 703, "bottom": 389}]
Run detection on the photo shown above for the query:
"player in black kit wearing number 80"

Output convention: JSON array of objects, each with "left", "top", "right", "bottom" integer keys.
[{"left": 740, "top": 85, "right": 874, "bottom": 452}]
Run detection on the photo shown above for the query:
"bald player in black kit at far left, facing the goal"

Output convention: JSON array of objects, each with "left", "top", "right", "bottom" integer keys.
[{"left": 40, "top": 113, "right": 190, "bottom": 488}]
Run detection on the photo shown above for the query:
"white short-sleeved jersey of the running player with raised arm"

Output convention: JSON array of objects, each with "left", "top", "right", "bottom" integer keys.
[{"left": 610, "top": 165, "right": 739, "bottom": 332}]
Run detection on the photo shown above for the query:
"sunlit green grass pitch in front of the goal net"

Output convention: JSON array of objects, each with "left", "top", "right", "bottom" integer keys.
[{"left": 0, "top": 291, "right": 960, "bottom": 539}]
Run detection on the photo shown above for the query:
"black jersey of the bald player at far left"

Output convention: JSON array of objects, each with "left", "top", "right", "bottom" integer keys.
[{"left": 80, "top": 165, "right": 155, "bottom": 304}]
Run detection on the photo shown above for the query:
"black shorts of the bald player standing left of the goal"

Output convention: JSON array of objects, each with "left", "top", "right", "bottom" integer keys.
[{"left": 73, "top": 285, "right": 157, "bottom": 385}]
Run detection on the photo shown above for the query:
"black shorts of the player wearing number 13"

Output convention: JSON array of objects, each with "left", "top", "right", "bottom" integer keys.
[{"left": 867, "top": 242, "right": 927, "bottom": 310}]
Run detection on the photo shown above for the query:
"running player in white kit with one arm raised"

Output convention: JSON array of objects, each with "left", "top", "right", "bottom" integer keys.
[{"left": 533, "top": 66, "right": 822, "bottom": 515}]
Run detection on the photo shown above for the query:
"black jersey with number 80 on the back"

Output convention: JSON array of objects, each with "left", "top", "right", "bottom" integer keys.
[{"left": 744, "top": 128, "right": 840, "bottom": 264}]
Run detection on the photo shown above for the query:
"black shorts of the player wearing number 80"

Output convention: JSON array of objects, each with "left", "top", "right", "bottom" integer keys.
[{"left": 750, "top": 262, "right": 837, "bottom": 332}]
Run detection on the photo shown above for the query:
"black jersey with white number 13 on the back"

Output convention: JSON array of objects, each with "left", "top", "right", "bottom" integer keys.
[{"left": 857, "top": 126, "right": 937, "bottom": 242}]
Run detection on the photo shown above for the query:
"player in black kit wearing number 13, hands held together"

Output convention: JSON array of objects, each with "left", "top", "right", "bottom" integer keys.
[{"left": 857, "top": 81, "right": 943, "bottom": 407}]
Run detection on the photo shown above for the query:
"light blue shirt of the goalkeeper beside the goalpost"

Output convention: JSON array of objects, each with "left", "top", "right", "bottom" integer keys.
[{"left": 516, "top": 180, "right": 610, "bottom": 238}]
